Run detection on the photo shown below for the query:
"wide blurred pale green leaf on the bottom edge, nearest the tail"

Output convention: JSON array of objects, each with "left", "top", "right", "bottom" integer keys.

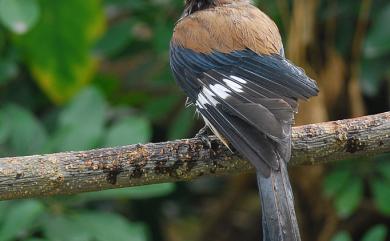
[{"left": 73, "top": 212, "right": 147, "bottom": 241}]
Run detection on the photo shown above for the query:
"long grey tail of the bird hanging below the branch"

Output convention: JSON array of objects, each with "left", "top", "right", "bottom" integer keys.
[{"left": 256, "top": 161, "right": 301, "bottom": 241}]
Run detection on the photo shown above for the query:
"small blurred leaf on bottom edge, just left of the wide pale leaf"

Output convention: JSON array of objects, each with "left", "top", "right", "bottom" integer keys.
[{"left": 43, "top": 216, "right": 93, "bottom": 241}]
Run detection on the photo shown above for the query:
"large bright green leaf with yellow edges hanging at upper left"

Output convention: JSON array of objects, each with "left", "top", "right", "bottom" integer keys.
[{"left": 16, "top": 0, "right": 104, "bottom": 103}]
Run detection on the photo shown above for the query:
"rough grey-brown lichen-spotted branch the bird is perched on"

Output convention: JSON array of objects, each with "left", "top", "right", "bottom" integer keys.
[{"left": 0, "top": 112, "right": 390, "bottom": 200}]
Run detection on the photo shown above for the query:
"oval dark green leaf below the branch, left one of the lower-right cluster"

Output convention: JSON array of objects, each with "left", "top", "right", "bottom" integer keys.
[{"left": 334, "top": 177, "right": 363, "bottom": 218}]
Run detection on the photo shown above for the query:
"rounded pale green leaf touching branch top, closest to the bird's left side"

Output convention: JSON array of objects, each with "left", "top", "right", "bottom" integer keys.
[{"left": 105, "top": 116, "right": 152, "bottom": 146}]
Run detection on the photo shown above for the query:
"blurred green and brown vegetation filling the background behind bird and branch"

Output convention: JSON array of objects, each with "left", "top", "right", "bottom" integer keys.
[{"left": 0, "top": 0, "right": 390, "bottom": 241}]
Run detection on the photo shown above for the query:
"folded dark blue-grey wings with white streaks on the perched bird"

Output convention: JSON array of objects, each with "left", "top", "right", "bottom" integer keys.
[{"left": 170, "top": 45, "right": 318, "bottom": 176}]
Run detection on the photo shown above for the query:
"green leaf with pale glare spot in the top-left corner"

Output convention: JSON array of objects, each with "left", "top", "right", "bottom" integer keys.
[{"left": 0, "top": 0, "right": 40, "bottom": 34}]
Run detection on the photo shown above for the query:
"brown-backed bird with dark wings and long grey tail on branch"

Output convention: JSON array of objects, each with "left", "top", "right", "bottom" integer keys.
[{"left": 169, "top": 0, "right": 319, "bottom": 241}]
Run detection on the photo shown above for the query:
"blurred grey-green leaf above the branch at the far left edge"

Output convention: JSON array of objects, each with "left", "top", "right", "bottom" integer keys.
[{"left": 3, "top": 105, "right": 48, "bottom": 155}]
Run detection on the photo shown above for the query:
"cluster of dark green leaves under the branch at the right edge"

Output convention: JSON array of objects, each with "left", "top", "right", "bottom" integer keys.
[{"left": 324, "top": 154, "right": 390, "bottom": 228}]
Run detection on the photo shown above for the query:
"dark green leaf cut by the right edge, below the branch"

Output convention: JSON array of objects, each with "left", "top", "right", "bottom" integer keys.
[{"left": 371, "top": 180, "right": 390, "bottom": 215}]
